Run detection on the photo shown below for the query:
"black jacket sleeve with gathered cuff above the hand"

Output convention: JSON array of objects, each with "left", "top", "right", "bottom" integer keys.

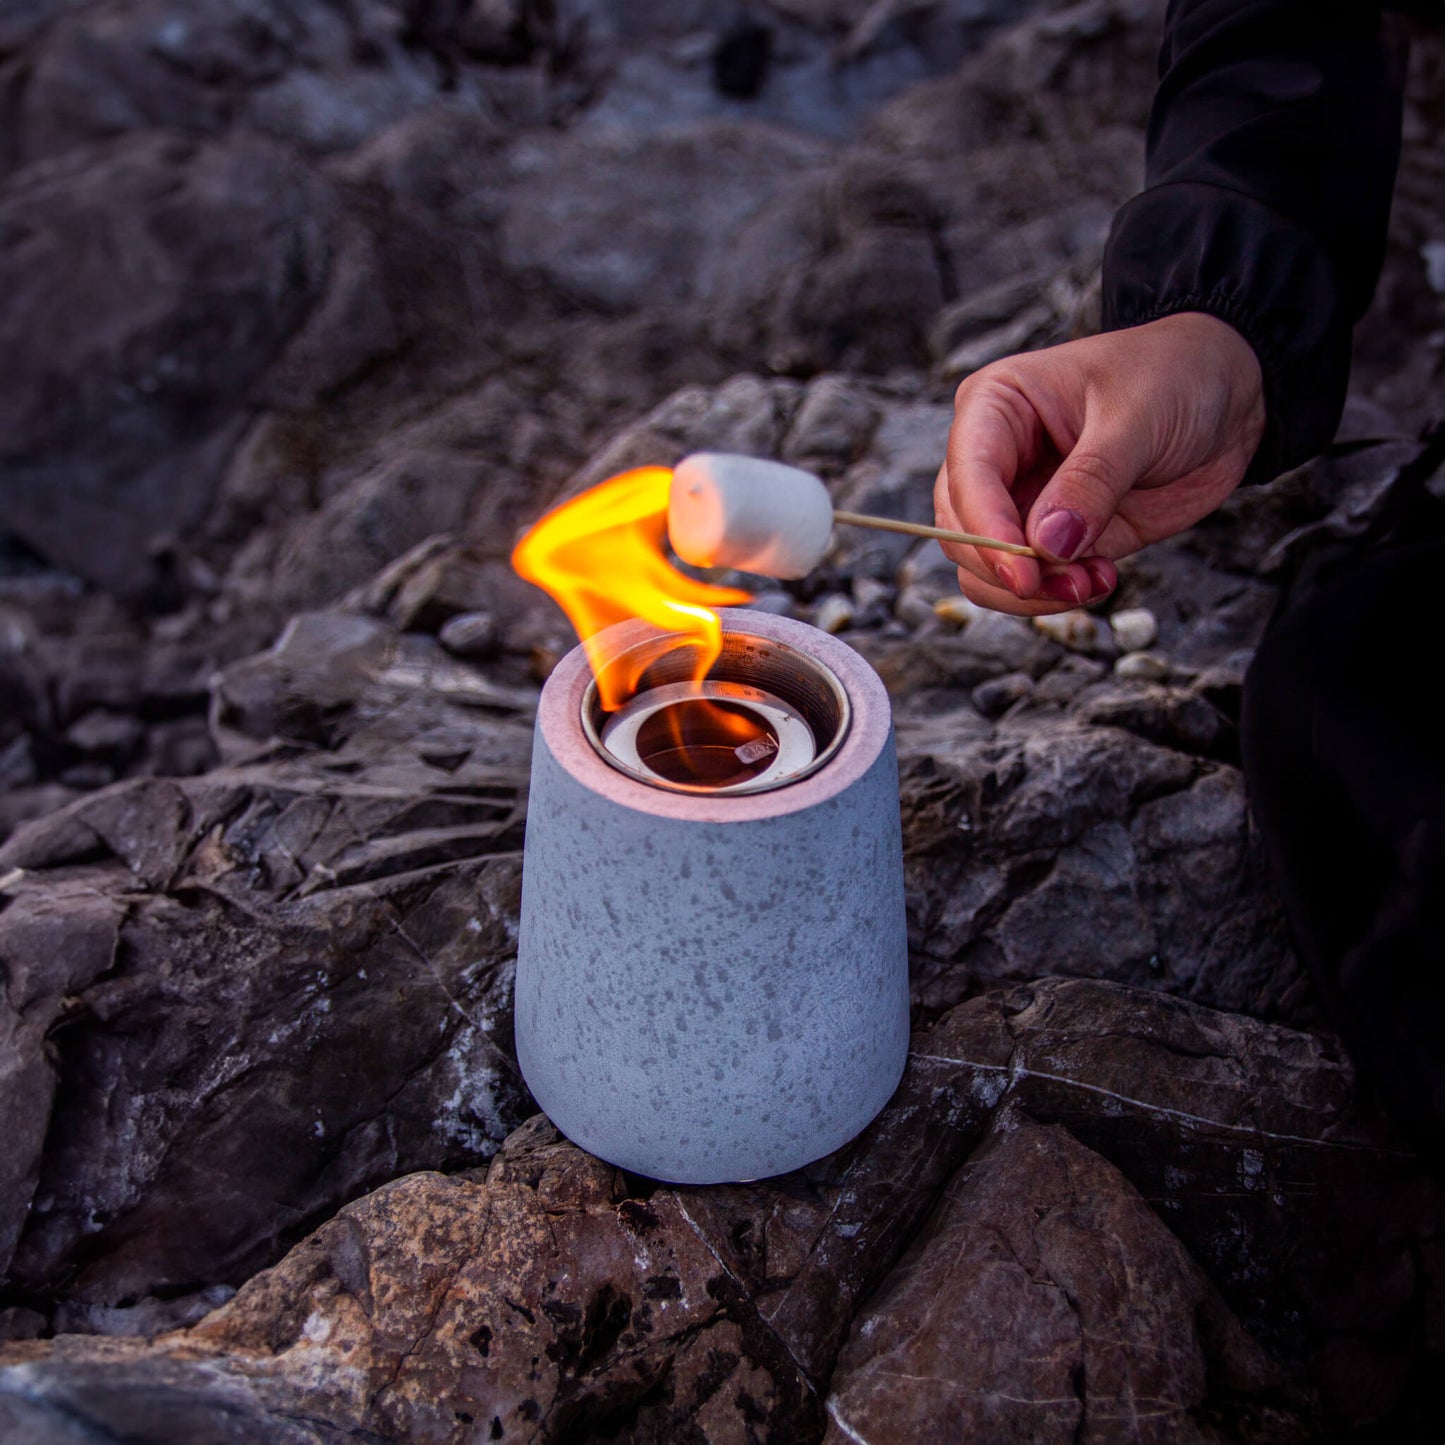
[{"left": 1104, "top": 0, "right": 1402, "bottom": 481}]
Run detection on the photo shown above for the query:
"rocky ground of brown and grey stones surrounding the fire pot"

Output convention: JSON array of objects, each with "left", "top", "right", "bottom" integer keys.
[{"left": 0, "top": 0, "right": 1445, "bottom": 1445}]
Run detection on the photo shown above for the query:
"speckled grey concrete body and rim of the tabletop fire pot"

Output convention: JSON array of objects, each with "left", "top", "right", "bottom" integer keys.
[{"left": 516, "top": 611, "right": 909, "bottom": 1183}]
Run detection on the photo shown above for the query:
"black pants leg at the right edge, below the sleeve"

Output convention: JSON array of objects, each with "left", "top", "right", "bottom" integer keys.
[{"left": 1241, "top": 448, "right": 1445, "bottom": 1157}]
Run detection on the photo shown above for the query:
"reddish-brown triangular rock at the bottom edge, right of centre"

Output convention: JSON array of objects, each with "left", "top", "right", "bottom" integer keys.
[{"left": 827, "top": 1113, "right": 1303, "bottom": 1445}]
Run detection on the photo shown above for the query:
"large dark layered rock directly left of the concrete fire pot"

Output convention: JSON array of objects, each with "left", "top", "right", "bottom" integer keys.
[{"left": 0, "top": 617, "right": 530, "bottom": 1308}]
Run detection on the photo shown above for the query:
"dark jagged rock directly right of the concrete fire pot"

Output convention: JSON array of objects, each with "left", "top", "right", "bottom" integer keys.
[{"left": 899, "top": 713, "right": 1299, "bottom": 1013}]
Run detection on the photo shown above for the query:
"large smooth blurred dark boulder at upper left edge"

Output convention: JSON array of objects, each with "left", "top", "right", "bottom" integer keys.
[{"left": 0, "top": 133, "right": 328, "bottom": 594}]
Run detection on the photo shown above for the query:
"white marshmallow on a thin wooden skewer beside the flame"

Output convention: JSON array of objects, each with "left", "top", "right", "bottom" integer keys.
[{"left": 668, "top": 452, "right": 832, "bottom": 577}]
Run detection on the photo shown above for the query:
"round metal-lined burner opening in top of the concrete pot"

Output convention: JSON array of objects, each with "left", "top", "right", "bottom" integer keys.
[{"left": 582, "top": 631, "right": 850, "bottom": 793}]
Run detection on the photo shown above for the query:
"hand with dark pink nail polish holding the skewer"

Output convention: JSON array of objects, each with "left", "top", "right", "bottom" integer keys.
[{"left": 933, "top": 311, "right": 1264, "bottom": 616}]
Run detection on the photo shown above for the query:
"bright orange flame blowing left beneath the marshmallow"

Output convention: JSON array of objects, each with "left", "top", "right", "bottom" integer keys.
[{"left": 512, "top": 467, "right": 751, "bottom": 711}]
